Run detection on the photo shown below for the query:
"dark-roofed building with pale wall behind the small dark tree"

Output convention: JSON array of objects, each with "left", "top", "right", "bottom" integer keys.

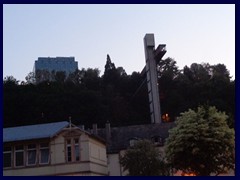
[{"left": 91, "top": 122, "right": 175, "bottom": 176}]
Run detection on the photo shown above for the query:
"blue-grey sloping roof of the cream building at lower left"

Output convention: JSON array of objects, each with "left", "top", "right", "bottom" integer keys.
[{"left": 3, "top": 121, "right": 69, "bottom": 142}]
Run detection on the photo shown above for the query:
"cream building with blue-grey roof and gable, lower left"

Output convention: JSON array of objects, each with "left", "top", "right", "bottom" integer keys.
[{"left": 3, "top": 121, "right": 107, "bottom": 176}]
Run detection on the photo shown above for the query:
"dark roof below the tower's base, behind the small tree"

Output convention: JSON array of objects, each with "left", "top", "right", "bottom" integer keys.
[{"left": 98, "top": 122, "right": 175, "bottom": 153}]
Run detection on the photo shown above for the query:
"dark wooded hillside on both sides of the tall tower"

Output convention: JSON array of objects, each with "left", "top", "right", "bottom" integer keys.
[{"left": 3, "top": 55, "right": 235, "bottom": 128}]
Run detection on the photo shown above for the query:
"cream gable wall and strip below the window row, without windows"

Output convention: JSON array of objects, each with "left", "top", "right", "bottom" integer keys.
[{"left": 3, "top": 129, "right": 107, "bottom": 176}]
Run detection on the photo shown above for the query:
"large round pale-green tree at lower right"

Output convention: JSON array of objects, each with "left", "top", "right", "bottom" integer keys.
[{"left": 166, "top": 106, "right": 234, "bottom": 176}]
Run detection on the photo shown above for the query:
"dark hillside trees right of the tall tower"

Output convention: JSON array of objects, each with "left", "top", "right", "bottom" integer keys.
[{"left": 159, "top": 58, "right": 235, "bottom": 127}]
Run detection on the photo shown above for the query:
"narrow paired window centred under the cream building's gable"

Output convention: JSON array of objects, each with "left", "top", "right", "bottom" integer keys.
[{"left": 66, "top": 138, "right": 80, "bottom": 162}]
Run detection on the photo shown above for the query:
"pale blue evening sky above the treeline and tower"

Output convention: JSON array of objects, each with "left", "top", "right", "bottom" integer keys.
[{"left": 3, "top": 4, "right": 235, "bottom": 81}]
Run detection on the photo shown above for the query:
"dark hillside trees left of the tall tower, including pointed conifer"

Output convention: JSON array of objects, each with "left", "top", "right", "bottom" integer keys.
[{"left": 3, "top": 56, "right": 149, "bottom": 128}]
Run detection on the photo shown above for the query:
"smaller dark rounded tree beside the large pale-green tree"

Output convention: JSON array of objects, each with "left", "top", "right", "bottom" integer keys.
[{"left": 120, "top": 140, "right": 169, "bottom": 176}]
